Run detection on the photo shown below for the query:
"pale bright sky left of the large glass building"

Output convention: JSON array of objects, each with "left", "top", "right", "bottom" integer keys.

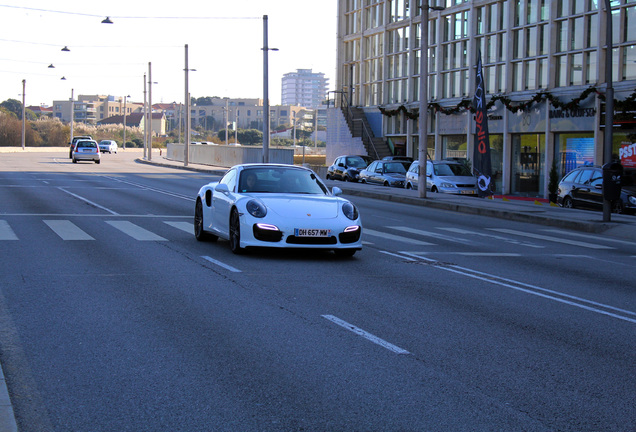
[{"left": 0, "top": 0, "right": 337, "bottom": 106}]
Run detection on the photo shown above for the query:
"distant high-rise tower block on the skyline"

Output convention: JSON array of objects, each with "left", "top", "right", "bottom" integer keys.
[{"left": 281, "top": 69, "right": 329, "bottom": 108}]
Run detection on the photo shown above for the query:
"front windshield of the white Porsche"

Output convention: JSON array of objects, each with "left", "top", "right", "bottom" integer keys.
[{"left": 239, "top": 167, "right": 328, "bottom": 195}]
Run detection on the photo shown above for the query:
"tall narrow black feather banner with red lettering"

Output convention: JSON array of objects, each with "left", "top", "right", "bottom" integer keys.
[{"left": 473, "top": 51, "right": 494, "bottom": 197}]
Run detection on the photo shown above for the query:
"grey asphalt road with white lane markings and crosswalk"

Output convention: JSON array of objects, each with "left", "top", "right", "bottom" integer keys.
[{"left": 0, "top": 152, "right": 636, "bottom": 432}]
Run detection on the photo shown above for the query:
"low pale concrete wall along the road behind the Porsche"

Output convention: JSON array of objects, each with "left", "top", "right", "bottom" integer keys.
[{"left": 166, "top": 143, "right": 294, "bottom": 168}]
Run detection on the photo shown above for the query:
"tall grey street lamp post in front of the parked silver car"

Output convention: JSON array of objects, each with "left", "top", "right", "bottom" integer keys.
[{"left": 417, "top": 4, "right": 444, "bottom": 198}]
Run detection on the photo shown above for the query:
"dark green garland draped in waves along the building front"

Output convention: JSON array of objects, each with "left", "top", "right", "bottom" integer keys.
[{"left": 378, "top": 87, "right": 636, "bottom": 120}]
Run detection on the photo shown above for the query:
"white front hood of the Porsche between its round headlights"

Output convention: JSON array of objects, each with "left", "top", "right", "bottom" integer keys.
[{"left": 253, "top": 194, "right": 341, "bottom": 219}]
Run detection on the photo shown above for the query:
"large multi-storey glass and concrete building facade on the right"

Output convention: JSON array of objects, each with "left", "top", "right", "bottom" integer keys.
[{"left": 336, "top": 0, "right": 636, "bottom": 196}]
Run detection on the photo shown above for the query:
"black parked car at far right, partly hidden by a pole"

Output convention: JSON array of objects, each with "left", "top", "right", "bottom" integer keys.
[{"left": 557, "top": 166, "right": 636, "bottom": 213}]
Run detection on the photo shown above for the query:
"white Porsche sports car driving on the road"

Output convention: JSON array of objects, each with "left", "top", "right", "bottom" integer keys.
[{"left": 194, "top": 164, "right": 362, "bottom": 256}]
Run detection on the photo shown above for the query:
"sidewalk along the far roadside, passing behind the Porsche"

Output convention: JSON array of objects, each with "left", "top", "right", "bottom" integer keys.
[{"left": 137, "top": 156, "right": 636, "bottom": 242}]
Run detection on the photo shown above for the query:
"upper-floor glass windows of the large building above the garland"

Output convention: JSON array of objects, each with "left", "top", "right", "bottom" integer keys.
[{"left": 343, "top": 0, "right": 636, "bottom": 104}]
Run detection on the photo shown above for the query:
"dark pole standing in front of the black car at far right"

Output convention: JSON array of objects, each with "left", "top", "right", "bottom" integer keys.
[{"left": 603, "top": 0, "right": 614, "bottom": 222}]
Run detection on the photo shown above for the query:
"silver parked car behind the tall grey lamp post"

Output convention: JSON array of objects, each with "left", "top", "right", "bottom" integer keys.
[{"left": 404, "top": 160, "right": 477, "bottom": 195}]
